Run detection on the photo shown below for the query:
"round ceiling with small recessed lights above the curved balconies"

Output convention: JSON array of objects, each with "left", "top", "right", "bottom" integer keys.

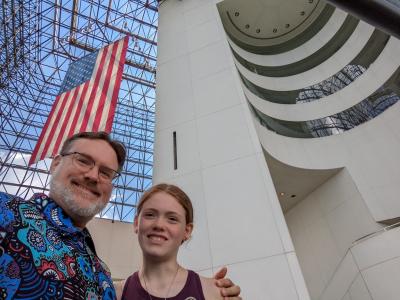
[{"left": 218, "top": 0, "right": 333, "bottom": 52}]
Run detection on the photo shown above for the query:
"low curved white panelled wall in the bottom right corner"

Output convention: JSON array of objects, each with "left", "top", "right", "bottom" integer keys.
[{"left": 306, "top": 228, "right": 400, "bottom": 300}]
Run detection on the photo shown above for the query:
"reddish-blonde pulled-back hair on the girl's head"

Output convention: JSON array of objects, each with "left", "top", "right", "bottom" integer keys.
[{"left": 136, "top": 183, "right": 193, "bottom": 224}]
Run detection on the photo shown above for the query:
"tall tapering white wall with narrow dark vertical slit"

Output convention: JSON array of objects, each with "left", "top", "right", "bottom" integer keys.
[{"left": 154, "top": 0, "right": 309, "bottom": 300}]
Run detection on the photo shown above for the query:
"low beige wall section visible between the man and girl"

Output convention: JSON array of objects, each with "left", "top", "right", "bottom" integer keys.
[{"left": 87, "top": 218, "right": 142, "bottom": 280}]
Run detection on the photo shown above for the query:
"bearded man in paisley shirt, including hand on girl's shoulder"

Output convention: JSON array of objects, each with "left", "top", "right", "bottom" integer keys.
[{"left": 0, "top": 132, "right": 241, "bottom": 299}]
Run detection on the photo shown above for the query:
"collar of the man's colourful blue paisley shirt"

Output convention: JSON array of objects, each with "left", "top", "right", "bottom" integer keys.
[{"left": 31, "top": 194, "right": 82, "bottom": 234}]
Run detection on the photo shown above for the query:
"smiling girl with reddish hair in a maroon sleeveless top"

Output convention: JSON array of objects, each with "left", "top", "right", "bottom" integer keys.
[{"left": 116, "top": 184, "right": 241, "bottom": 300}]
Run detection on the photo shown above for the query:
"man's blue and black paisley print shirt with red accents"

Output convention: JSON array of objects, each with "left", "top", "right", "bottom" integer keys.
[{"left": 0, "top": 192, "right": 116, "bottom": 300}]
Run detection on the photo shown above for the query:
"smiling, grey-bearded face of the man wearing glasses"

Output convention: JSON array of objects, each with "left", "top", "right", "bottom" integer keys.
[{"left": 49, "top": 138, "right": 118, "bottom": 227}]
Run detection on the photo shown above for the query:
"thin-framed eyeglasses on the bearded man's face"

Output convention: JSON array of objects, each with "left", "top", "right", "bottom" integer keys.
[{"left": 60, "top": 152, "right": 121, "bottom": 183}]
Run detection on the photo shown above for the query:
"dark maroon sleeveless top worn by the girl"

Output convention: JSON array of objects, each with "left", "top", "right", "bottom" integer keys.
[{"left": 122, "top": 270, "right": 205, "bottom": 300}]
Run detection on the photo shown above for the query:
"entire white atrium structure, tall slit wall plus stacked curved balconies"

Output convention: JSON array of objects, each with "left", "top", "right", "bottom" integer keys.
[{"left": 154, "top": 0, "right": 400, "bottom": 300}]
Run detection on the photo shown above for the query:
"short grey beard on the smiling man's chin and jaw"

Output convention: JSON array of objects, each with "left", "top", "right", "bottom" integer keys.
[{"left": 50, "top": 178, "right": 107, "bottom": 219}]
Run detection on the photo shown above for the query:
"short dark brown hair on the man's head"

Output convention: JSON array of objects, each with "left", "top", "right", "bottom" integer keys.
[{"left": 60, "top": 131, "right": 126, "bottom": 172}]
